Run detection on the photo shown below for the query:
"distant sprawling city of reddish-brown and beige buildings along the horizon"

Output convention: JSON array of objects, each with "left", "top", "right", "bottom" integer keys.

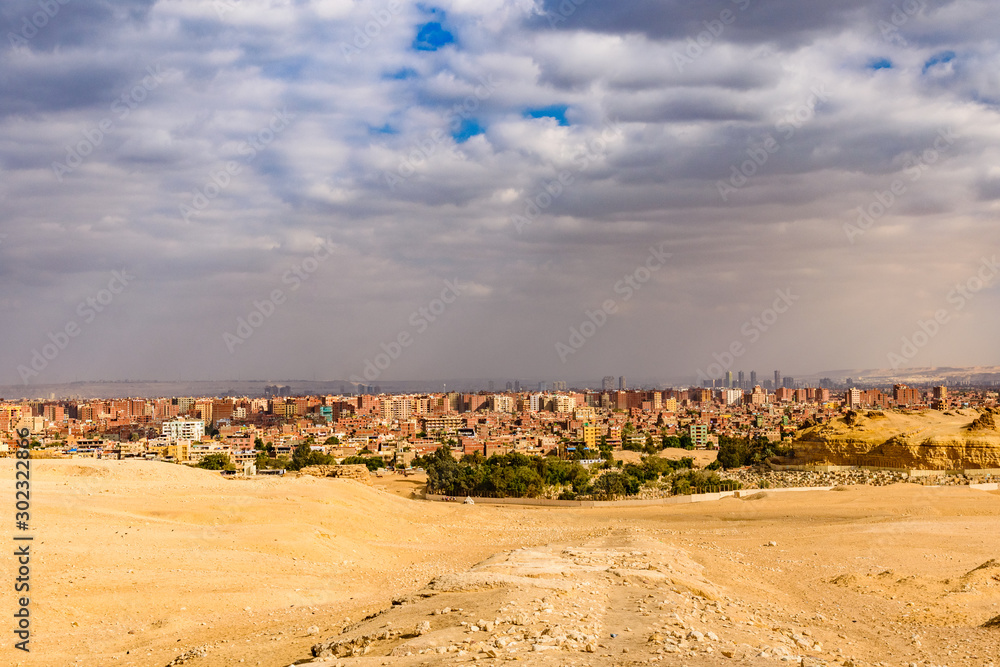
[{"left": 0, "top": 370, "right": 998, "bottom": 467}]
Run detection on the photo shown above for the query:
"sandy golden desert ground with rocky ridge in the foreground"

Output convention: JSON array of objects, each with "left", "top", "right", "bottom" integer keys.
[{"left": 0, "top": 459, "right": 1000, "bottom": 667}]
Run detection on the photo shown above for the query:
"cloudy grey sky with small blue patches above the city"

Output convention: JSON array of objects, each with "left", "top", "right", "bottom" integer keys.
[{"left": 0, "top": 0, "right": 1000, "bottom": 384}]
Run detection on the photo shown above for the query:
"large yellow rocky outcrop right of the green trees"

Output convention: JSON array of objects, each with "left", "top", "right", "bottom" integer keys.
[{"left": 792, "top": 410, "right": 1000, "bottom": 470}]
